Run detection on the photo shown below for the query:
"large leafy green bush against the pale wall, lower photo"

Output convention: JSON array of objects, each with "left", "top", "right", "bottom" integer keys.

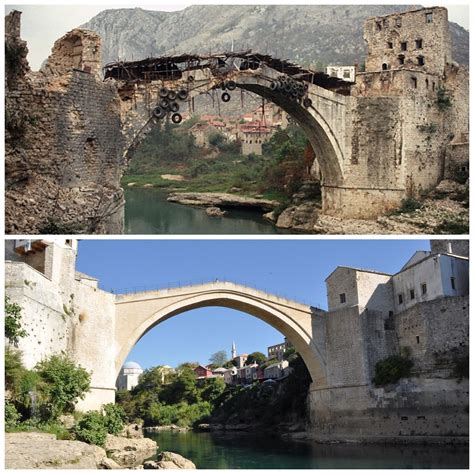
[{"left": 35, "top": 354, "right": 90, "bottom": 420}]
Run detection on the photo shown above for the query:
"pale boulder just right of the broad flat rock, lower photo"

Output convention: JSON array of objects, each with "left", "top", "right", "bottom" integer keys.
[{"left": 104, "top": 434, "right": 158, "bottom": 467}]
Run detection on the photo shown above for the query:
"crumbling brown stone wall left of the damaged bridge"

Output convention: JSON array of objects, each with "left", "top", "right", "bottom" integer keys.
[{"left": 5, "top": 12, "right": 124, "bottom": 234}]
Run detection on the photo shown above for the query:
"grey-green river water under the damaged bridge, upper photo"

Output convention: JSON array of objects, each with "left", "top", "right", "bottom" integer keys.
[{"left": 125, "top": 188, "right": 288, "bottom": 234}]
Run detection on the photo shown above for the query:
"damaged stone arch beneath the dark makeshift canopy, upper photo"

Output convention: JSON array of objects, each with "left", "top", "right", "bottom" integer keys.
[{"left": 115, "top": 63, "right": 349, "bottom": 191}]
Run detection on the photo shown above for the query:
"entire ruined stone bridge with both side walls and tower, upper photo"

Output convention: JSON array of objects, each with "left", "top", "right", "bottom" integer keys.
[{"left": 6, "top": 8, "right": 468, "bottom": 232}]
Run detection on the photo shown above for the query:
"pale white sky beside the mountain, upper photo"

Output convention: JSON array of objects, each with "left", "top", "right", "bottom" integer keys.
[{"left": 5, "top": 0, "right": 469, "bottom": 70}]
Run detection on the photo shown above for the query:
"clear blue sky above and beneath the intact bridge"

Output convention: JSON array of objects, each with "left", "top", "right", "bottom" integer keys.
[{"left": 77, "top": 240, "right": 429, "bottom": 368}]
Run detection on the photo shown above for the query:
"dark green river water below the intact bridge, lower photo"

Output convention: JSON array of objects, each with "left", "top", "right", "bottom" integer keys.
[{"left": 147, "top": 431, "right": 469, "bottom": 469}]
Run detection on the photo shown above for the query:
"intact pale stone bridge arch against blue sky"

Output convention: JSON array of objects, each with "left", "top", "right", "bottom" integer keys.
[{"left": 115, "top": 282, "right": 327, "bottom": 387}]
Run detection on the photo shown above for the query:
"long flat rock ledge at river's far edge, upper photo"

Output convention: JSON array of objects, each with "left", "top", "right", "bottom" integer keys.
[{"left": 168, "top": 193, "right": 279, "bottom": 212}]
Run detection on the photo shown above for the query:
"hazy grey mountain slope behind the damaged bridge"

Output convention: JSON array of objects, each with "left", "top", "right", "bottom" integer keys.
[{"left": 82, "top": 5, "right": 469, "bottom": 66}]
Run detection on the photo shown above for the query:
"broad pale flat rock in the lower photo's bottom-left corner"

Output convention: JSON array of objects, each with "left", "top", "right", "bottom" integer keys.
[{"left": 5, "top": 433, "right": 120, "bottom": 469}]
